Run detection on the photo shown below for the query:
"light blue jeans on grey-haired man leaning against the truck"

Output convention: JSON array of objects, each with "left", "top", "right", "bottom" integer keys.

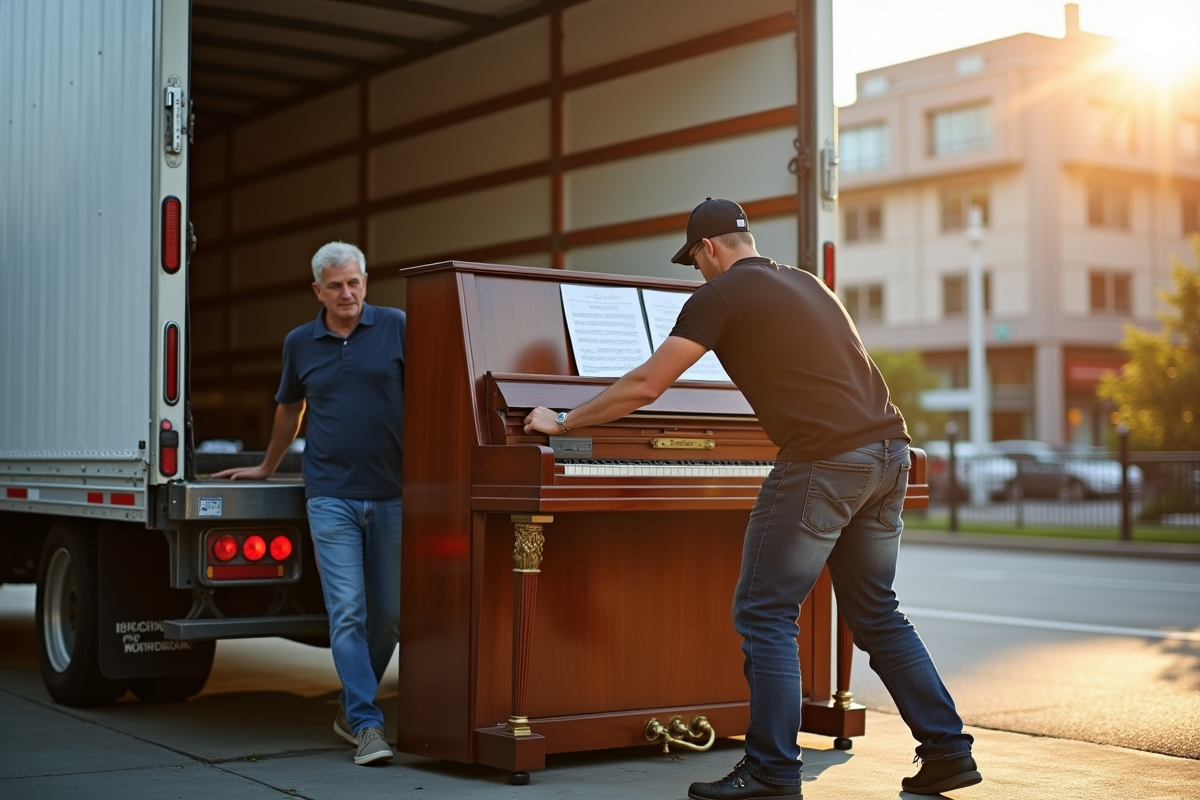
[{"left": 308, "top": 498, "right": 401, "bottom": 735}]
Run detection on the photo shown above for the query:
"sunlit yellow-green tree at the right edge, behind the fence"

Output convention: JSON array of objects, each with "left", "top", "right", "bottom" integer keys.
[{"left": 1097, "top": 233, "right": 1200, "bottom": 450}]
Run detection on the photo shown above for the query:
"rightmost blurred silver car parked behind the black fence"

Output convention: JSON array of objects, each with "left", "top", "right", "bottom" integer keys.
[{"left": 994, "top": 439, "right": 1144, "bottom": 500}]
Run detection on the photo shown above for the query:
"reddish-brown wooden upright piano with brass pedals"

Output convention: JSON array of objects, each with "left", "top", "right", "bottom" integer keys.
[{"left": 397, "top": 261, "right": 928, "bottom": 782}]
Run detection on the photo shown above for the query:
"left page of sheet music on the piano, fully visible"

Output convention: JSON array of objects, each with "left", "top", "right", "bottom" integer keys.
[{"left": 559, "top": 283, "right": 650, "bottom": 378}]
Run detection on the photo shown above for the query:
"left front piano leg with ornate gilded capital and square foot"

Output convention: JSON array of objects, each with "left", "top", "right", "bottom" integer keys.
[{"left": 475, "top": 515, "right": 554, "bottom": 786}]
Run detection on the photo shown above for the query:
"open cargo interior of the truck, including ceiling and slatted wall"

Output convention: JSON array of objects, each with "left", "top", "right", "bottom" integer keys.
[{"left": 188, "top": 0, "right": 832, "bottom": 450}]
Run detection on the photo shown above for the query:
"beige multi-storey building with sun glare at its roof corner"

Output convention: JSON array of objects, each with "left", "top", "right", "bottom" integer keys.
[{"left": 838, "top": 4, "right": 1200, "bottom": 444}]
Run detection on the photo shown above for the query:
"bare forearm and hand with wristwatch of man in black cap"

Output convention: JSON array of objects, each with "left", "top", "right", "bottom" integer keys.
[{"left": 524, "top": 336, "right": 708, "bottom": 434}]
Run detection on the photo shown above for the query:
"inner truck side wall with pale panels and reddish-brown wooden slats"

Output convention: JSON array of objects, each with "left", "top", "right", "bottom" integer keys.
[{"left": 192, "top": 0, "right": 797, "bottom": 431}]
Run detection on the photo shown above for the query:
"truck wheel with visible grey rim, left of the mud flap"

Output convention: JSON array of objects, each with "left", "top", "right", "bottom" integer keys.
[{"left": 36, "top": 523, "right": 125, "bottom": 706}]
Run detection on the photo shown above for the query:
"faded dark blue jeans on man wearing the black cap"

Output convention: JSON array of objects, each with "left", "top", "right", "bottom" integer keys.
[{"left": 733, "top": 440, "right": 973, "bottom": 786}]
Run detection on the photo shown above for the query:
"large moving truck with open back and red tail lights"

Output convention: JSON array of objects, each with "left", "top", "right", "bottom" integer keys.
[{"left": 0, "top": 0, "right": 836, "bottom": 705}]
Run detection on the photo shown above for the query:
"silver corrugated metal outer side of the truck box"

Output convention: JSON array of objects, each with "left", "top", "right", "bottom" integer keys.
[{"left": 0, "top": 0, "right": 157, "bottom": 459}]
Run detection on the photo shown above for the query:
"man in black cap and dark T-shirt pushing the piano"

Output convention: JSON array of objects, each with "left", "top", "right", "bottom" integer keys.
[{"left": 526, "top": 198, "right": 982, "bottom": 800}]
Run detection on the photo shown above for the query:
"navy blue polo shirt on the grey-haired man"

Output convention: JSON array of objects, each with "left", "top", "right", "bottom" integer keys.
[{"left": 275, "top": 303, "right": 406, "bottom": 500}]
